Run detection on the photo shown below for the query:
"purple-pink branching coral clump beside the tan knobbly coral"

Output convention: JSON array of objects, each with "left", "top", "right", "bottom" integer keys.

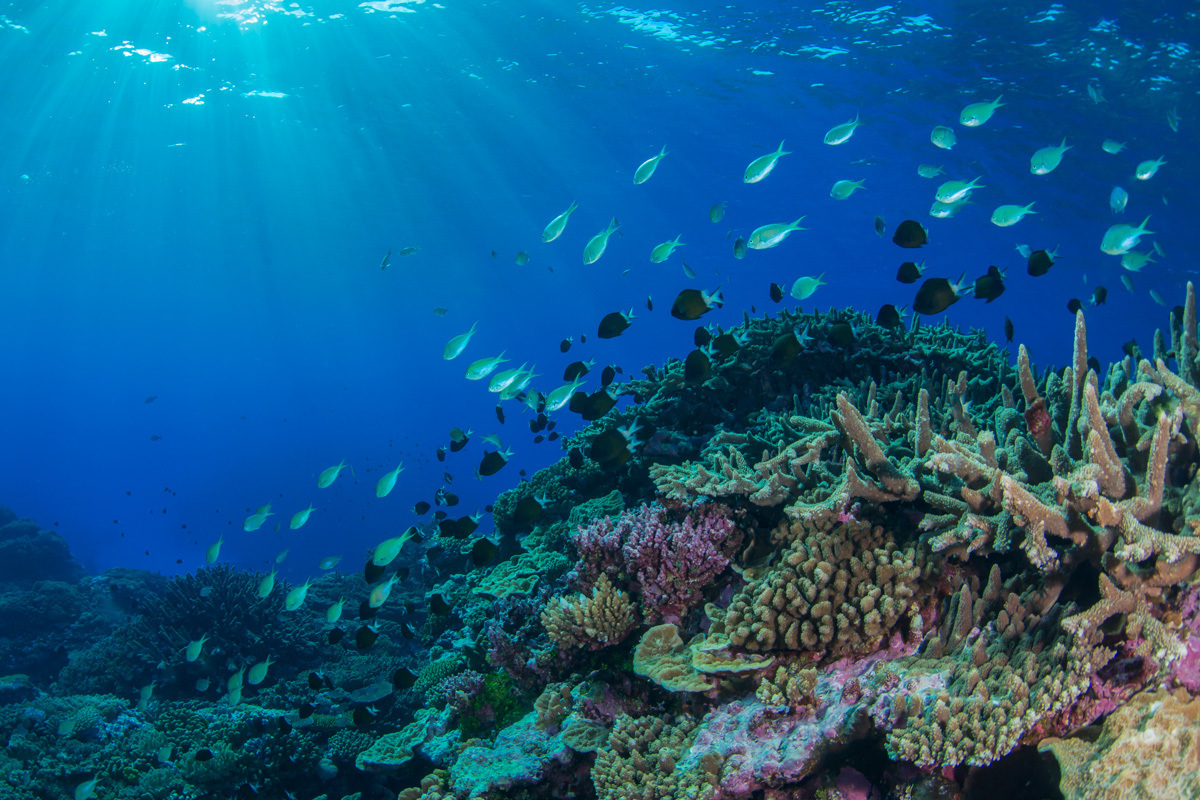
[{"left": 571, "top": 503, "right": 740, "bottom": 622}]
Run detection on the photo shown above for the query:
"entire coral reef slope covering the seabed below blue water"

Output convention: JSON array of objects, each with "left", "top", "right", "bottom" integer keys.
[{"left": 0, "top": 284, "right": 1200, "bottom": 800}]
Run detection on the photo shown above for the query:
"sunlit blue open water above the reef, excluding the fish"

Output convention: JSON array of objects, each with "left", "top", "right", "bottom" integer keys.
[{"left": 0, "top": 0, "right": 1200, "bottom": 579}]
